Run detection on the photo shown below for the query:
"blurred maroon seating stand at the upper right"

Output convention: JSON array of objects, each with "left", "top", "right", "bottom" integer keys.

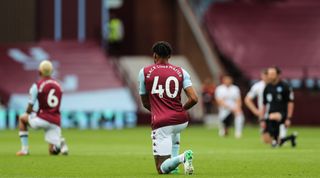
[{"left": 204, "top": 0, "right": 320, "bottom": 80}]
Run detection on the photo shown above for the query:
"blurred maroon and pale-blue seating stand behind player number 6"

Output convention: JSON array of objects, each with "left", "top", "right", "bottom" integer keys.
[{"left": 0, "top": 41, "right": 136, "bottom": 128}]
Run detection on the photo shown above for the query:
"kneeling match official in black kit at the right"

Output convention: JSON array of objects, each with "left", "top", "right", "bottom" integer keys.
[{"left": 262, "top": 67, "right": 297, "bottom": 147}]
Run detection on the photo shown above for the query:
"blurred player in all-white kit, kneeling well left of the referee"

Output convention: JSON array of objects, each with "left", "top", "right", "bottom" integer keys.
[{"left": 215, "top": 75, "right": 244, "bottom": 138}]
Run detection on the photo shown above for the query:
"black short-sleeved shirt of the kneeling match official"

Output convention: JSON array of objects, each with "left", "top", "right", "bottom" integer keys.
[{"left": 263, "top": 80, "right": 294, "bottom": 117}]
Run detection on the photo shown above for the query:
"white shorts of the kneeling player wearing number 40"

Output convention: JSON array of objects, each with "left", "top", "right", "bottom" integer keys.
[{"left": 151, "top": 122, "right": 188, "bottom": 156}]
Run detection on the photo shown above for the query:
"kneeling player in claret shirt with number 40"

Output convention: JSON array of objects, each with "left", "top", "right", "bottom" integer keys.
[{"left": 139, "top": 41, "right": 198, "bottom": 174}]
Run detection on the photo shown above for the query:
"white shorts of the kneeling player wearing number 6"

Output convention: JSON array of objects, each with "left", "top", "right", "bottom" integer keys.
[{"left": 28, "top": 113, "right": 61, "bottom": 146}]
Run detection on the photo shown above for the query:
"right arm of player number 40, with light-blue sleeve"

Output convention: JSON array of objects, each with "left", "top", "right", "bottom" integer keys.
[{"left": 182, "top": 69, "right": 198, "bottom": 110}]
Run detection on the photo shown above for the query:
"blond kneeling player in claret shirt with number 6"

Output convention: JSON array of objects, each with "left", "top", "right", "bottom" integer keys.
[{"left": 16, "top": 60, "right": 68, "bottom": 156}]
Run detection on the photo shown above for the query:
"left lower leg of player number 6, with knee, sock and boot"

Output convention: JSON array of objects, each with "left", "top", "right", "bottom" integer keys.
[{"left": 16, "top": 113, "right": 29, "bottom": 156}]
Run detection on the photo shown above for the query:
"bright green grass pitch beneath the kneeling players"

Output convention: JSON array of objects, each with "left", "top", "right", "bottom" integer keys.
[{"left": 0, "top": 126, "right": 320, "bottom": 178}]
